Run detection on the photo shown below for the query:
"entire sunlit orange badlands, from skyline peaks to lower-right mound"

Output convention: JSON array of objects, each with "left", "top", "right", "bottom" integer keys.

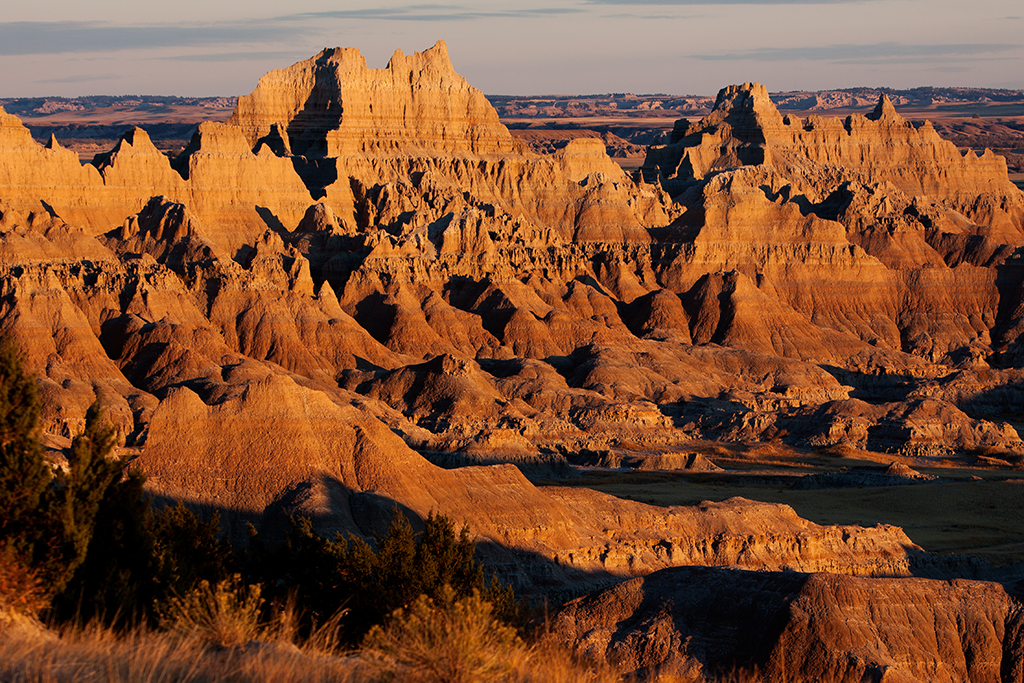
[{"left": 0, "top": 43, "right": 1024, "bottom": 681}]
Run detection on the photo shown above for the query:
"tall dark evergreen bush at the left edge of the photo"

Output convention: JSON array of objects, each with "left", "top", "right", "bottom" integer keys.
[{"left": 0, "top": 342, "right": 230, "bottom": 623}]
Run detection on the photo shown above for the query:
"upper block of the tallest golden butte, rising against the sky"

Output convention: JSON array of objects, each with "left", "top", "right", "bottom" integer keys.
[{"left": 227, "top": 42, "right": 521, "bottom": 159}]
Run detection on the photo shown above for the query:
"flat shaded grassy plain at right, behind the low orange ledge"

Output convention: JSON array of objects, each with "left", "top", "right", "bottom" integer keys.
[{"left": 548, "top": 446, "right": 1024, "bottom": 565}]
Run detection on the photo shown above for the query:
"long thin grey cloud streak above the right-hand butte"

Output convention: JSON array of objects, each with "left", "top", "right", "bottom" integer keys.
[{"left": 690, "top": 43, "right": 1021, "bottom": 65}]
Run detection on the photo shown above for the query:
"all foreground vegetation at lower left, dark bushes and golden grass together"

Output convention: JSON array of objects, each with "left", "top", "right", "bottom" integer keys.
[{"left": 0, "top": 337, "right": 617, "bottom": 683}]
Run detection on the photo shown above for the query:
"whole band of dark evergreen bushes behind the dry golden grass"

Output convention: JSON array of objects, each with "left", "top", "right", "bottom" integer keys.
[{"left": 0, "top": 335, "right": 517, "bottom": 643}]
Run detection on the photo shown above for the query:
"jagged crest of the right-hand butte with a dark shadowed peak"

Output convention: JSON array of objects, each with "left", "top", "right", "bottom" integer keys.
[{"left": 645, "top": 83, "right": 1024, "bottom": 232}]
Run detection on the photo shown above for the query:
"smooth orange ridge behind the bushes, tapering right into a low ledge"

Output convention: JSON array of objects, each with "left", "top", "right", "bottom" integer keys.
[{"left": 139, "top": 370, "right": 921, "bottom": 591}]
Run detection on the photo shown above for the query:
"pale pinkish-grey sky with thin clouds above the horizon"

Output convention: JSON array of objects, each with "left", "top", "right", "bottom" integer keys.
[{"left": 0, "top": 0, "right": 1024, "bottom": 97}]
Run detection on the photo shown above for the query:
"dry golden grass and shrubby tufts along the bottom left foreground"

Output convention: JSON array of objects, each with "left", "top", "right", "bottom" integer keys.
[{"left": 0, "top": 582, "right": 621, "bottom": 683}]
